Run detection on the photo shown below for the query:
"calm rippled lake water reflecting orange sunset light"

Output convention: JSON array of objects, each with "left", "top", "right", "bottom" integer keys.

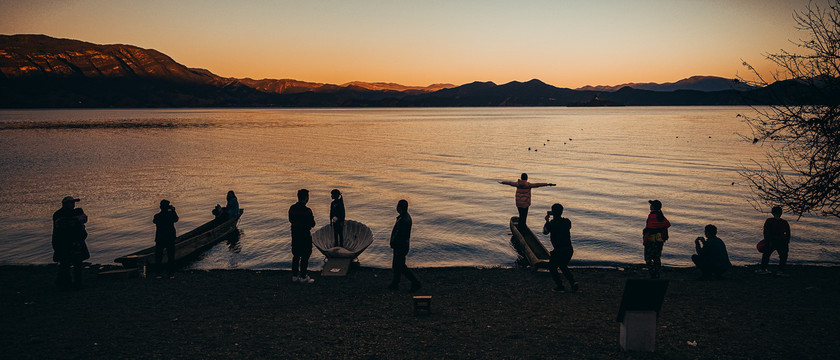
[{"left": 0, "top": 107, "right": 840, "bottom": 269}]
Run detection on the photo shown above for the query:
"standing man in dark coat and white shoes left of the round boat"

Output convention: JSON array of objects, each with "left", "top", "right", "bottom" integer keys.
[{"left": 289, "top": 189, "right": 315, "bottom": 284}]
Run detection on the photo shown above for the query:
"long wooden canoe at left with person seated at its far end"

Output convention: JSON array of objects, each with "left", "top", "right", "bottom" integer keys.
[{"left": 114, "top": 209, "right": 245, "bottom": 268}]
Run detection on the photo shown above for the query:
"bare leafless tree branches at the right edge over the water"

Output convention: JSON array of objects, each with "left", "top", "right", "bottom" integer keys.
[{"left": 739, "top": 0, "right": 840, "bottom": 218}]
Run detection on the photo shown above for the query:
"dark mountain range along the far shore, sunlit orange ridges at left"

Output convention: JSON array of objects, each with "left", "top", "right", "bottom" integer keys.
[{"left": 0, "top": 35, "right": 802, "bottom": 108}]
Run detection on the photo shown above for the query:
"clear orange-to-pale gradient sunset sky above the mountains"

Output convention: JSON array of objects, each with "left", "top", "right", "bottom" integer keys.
[{"left": 0, "top": 0, "right": 808, "bottom": 88}]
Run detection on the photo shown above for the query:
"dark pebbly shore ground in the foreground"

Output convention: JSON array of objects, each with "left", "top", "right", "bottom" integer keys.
[{"left": 0, "top": 266, "right": 840, "bottom": 359}]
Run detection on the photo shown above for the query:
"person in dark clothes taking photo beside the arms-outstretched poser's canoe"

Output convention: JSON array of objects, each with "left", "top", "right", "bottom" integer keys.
[{"left": 543, "top": 204, "right": 578, "bottom": 292}]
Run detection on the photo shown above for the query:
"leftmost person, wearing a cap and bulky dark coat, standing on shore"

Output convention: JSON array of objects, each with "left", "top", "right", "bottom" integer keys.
[{"left": 52, "top": 196, "right": 90, "bottom": 290}]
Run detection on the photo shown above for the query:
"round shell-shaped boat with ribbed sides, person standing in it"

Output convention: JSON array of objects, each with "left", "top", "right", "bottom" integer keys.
[{"left": 312, "top": 220, "right": 373, "bottom": 259}]
